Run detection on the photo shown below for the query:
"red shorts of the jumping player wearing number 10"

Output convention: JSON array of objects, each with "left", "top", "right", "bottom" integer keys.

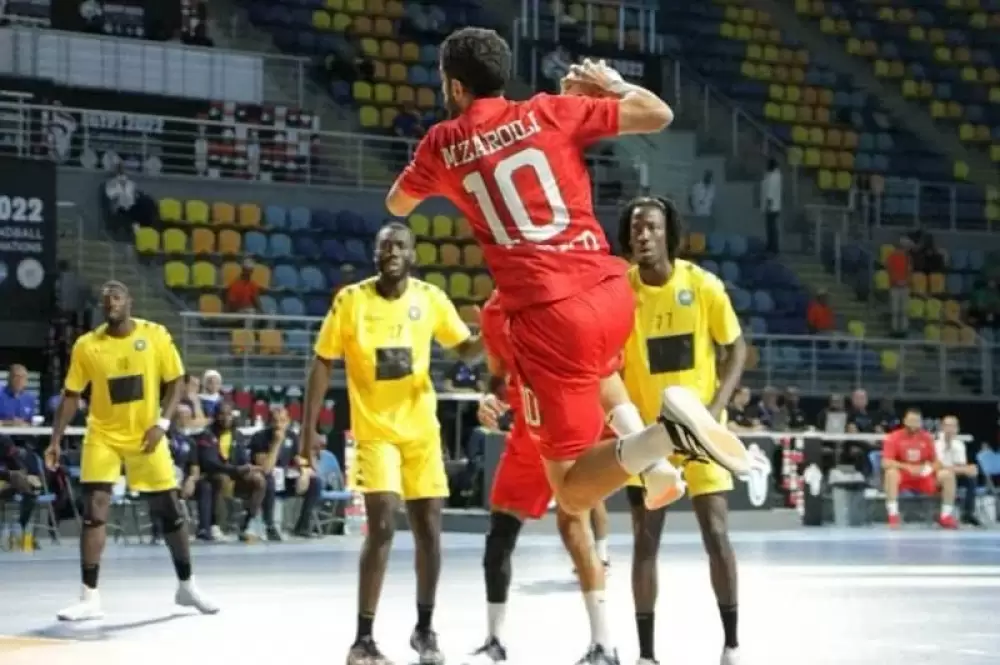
[{"left": 510, "top": 275, "right": 635, "bottom": 461}]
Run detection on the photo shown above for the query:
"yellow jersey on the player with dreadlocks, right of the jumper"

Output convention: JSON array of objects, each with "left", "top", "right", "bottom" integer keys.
[{"left": 622, "top": 259, "right": 742, "bottom": 423}]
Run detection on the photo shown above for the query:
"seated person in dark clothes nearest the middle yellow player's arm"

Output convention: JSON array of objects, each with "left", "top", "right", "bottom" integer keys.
[{"left": 250, "top": 405, "right": 323, "bottom": 540}]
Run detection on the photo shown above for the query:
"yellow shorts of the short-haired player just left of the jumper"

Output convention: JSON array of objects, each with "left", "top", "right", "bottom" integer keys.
[{"left": 348, "top": 438, "right": 449, "bottom": 501}]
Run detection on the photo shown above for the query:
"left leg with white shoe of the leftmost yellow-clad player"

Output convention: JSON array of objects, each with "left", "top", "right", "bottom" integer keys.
[{"left": 57, "top": 483, "right": 111, "bottom": 621}]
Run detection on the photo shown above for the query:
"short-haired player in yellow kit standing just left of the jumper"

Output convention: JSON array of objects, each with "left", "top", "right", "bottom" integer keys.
[{"left": 301, "top": 223, "right": 483, "bottom": 665}]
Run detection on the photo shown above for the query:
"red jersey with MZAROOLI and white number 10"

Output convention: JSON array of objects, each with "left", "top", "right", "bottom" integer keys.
[{"left": 399, "top": 94, "right": 627, "bottom": 311}]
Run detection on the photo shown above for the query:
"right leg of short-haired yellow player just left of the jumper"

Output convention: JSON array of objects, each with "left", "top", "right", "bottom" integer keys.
[{"left": 406, "top": 499, "right": 444, "bottom": 665}]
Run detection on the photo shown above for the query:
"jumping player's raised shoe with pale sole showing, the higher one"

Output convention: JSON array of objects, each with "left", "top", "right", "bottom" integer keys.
[{"left": 660, "top": 386, "right": 750, "bottom": 476}]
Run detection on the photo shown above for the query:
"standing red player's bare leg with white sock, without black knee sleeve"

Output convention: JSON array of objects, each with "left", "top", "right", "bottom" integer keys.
[{"left": 556, "top": 510, "right": 618, "bottom": 665}]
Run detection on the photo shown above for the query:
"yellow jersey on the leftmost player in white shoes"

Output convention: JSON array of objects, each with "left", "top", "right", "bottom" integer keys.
[{"left": 63, "top": 319, "right": 184, "bottom": 445}]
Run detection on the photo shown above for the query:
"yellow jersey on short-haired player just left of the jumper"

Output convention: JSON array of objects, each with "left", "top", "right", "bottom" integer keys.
[{"left": 314, "top": 277, "right": 472, "bottom": 442}]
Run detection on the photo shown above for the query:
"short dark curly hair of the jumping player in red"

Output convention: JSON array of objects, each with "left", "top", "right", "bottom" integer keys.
[{"left": 441, "top": 28, "right": 512, "bottom": 98}]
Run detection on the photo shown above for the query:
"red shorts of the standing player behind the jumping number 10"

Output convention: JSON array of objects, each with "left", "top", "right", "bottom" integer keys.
[{"left": 490, "top": 432, "right": 552, "bottom": 520}]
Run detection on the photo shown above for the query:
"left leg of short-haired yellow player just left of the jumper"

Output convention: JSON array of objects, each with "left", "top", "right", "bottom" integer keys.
[{"left": 347, "top": 492, "right": 399, "bottom": 665}]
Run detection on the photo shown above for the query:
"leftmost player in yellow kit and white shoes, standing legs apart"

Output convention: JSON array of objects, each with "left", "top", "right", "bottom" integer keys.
[{"left": 45, "top": 281, "right": 218, "bottom": 621}]
